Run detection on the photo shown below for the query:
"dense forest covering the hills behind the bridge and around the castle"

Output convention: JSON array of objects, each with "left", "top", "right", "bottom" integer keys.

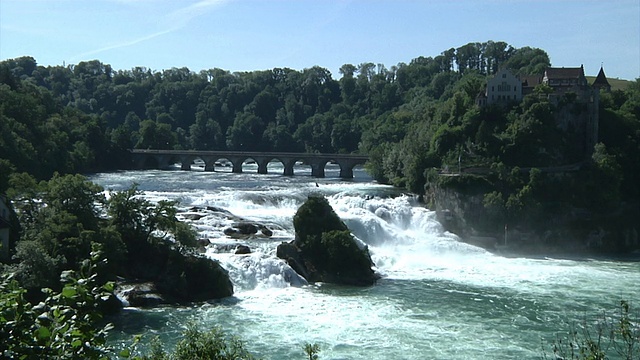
[{"left": 0, "top": 41, "right": 640, "bottom": 248}]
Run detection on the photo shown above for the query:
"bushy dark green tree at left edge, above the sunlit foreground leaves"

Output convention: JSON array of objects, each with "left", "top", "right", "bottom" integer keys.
[{"left": 9, "top": 174, "right": 109, "bottom": 290}]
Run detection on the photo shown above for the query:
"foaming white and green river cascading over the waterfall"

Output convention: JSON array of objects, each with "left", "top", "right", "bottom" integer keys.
[{"left": 90, "top": 164, "right": 640, "bottom": 360}]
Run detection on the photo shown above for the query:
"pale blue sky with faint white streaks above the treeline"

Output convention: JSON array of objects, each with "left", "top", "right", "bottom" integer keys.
[{"left": 0, "top": 0, "right": 640, "bottom": 80}]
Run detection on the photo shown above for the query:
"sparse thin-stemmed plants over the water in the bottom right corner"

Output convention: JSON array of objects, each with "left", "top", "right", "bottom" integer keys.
[{"left": 544, "top": 300, "right": 640, "bottom": 360}]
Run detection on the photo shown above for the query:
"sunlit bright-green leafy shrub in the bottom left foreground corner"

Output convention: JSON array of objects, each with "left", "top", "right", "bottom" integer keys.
[{"left": 0, "top": 247, "right": 113, "bottom": 359}]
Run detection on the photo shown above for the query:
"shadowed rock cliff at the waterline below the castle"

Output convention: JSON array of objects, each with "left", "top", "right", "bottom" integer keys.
[{"left": 426, "top": 175, "right": 640, "bottom": 255}]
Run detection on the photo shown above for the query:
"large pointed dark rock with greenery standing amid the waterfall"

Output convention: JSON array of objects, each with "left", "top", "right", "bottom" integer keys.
[{"left": 277, "top": 196, "right": 379, "bottom": 286}]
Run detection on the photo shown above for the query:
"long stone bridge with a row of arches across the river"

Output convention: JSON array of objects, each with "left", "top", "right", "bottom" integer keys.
[{"left": 129, "top": 149, "right": 369, "bottom": 179}]
